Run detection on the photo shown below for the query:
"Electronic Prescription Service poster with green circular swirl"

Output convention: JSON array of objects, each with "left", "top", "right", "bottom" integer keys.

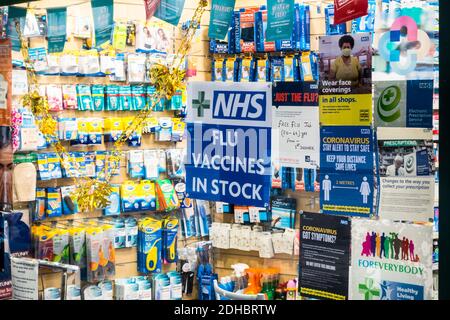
[{"left": 374, "top": 80, "right": 433, "bottom": 128}]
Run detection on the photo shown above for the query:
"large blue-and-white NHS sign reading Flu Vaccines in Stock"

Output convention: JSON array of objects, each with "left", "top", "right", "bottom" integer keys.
[{"left": 185, "top": 82, "right": 272, "bottom": 207}]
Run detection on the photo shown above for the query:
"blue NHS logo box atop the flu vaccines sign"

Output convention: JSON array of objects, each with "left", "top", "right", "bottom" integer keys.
[{"left": 212, "top": 90, "right": 267, "bottom": 121}]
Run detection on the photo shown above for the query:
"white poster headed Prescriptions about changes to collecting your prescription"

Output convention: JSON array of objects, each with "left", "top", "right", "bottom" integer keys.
[{"left": 377, "top": 128, "right": 435, "bottom": 222}]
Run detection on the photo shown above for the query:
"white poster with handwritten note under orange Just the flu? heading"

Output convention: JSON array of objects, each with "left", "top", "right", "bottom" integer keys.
[{"left": 272, "top": 82, "right": 320, "bottom": 169}]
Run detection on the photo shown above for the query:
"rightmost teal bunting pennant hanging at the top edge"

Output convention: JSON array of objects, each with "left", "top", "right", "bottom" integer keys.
[{"left": 266, "top": 0, "right": 294, "bottom": 41}]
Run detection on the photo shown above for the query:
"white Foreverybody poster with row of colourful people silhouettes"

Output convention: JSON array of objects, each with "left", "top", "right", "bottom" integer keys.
[{"left": 349, "top": 219, "right": 433, "bottom": 300}]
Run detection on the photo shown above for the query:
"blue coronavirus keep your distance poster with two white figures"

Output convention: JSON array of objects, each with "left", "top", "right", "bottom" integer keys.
[{"left": 320, "top": 126, "right": 374, "bottom": 217}]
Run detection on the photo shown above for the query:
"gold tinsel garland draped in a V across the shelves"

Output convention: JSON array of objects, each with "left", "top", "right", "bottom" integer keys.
[{"left": 16, "top": 0, "right": 208, "bottom": 212}]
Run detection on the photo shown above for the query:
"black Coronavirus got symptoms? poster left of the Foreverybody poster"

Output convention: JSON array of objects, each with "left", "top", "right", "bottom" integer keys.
[{"left": 299, "top": 212, "right": 351, "bottom": 300}]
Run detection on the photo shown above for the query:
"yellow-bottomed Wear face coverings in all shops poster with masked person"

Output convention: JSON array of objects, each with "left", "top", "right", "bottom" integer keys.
[{"left": 319, "top": 33, "right": 372, "bottom": 126}]
